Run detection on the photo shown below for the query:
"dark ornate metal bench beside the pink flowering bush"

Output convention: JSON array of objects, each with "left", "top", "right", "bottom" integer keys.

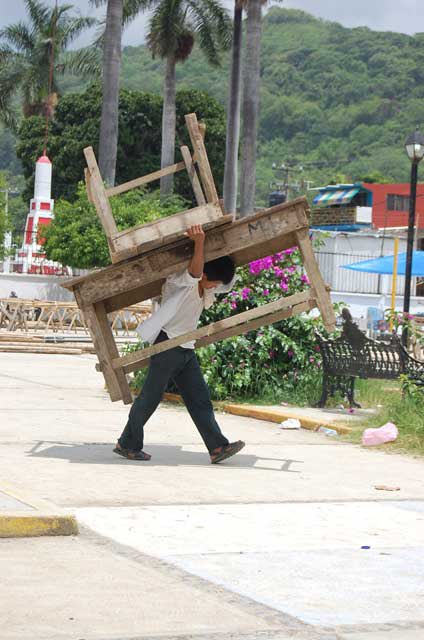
[{"left": 316, "top": 309, "right": 424, "bottom": 407}]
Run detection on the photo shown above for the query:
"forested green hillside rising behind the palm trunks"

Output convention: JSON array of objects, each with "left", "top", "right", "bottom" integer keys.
[{"left": 7, "top": 7, "right": 424, "bottom": 200}]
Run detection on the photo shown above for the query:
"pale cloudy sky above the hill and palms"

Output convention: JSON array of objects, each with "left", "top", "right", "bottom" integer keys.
[{"left": 0, "top": 0, "right": 424, "bottom": 45}]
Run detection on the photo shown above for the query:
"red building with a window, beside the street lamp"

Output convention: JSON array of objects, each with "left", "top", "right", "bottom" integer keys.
[{"left": 362, "top": 183, "right": 424, "bottom": 229}]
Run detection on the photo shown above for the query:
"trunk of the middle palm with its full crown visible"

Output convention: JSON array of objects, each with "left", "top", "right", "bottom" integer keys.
[{"left": 160, "top": 57, "right": 177, "bottom": 198}]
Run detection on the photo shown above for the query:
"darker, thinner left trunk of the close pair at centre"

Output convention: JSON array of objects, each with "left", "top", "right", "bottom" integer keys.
[{"left": 224, "top": 0, "right": 243, "bottom": 215}]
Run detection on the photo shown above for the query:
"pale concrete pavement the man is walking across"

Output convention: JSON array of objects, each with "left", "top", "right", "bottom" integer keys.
[{"left": 0, "top": 354, "right": 424, "bottom": 640}]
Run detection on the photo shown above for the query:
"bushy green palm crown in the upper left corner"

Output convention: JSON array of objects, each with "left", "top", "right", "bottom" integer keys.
[{"left": 0, "top": 0, "right": 98, "bottom": 128}]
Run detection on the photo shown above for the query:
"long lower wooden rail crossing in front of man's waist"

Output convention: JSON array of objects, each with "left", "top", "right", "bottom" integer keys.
[{"left": 112, "top": 290, "right": 313, "bottom": 370}]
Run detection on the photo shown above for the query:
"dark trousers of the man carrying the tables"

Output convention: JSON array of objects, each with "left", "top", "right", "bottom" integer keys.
[{"left": 118, "top": 332, "right": 228, "bottom": 453}]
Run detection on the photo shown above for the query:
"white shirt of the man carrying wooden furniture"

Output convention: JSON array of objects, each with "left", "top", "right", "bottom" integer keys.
[{"left": 137, "top": 269, "right": 236, "bottom": 349}]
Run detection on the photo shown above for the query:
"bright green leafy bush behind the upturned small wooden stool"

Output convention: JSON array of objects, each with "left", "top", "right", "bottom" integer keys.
[{"left": 45, "top": 183, "right": 184, "bottom": 269}]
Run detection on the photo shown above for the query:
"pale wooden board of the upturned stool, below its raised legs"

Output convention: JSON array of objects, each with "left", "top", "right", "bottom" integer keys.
[{"left": 112, "top": 204, "right": 222, "bottom": 259}]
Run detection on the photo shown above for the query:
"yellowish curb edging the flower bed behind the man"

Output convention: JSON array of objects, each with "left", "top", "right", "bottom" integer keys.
[{"left": 164, "top": 393, "right": 352, "bottom": 435}]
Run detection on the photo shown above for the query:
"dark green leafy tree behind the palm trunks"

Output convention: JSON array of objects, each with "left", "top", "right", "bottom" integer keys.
[{"left": 17, "top": 85, "right": 229, "bottom": 201}]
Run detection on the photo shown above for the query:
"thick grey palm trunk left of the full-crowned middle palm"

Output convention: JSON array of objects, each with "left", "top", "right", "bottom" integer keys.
[{"left": 99, "top": 0, "right": 123, "bottom": 186}]
